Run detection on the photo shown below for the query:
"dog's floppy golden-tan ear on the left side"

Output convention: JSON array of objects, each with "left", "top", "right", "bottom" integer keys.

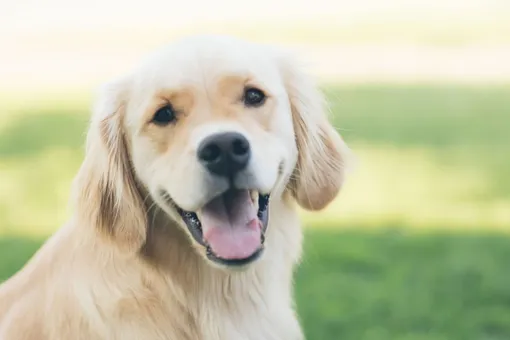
[{"left": 74, "top": 78, "right": 147, "bottom": 252}]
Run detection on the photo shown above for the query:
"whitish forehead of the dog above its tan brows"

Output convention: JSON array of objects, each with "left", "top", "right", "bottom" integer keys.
[{"left": 133, "top": 37, "right": 279, "bottom": 88}]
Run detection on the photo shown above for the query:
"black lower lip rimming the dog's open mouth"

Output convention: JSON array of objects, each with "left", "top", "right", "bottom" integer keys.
[{"left": 163, "top": 189, "right": 270, "bottom": 266}]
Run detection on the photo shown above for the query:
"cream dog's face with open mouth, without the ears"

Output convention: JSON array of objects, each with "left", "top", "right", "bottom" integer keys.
[{"left": 125, "top": 40, "right": 297, "bottom": 264}]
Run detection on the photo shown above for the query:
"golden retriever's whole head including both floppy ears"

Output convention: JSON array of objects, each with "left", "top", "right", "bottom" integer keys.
[{"left": 72, "top": 37, "right": 346, "bottom": 265}]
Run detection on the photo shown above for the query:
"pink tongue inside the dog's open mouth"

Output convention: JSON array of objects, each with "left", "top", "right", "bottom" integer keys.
[{"left": 199, "top": 190, "right": 261, "bottom": 260}]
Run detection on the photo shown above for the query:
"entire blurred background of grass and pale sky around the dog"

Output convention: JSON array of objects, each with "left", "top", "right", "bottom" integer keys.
[{"left": 0, "top": 0, "right": 510, "bottom": 340}]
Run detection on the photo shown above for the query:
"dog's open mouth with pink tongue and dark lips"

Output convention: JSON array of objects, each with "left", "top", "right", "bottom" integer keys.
[{"left": 171, "top": 189, "right": 269, "bottom": 265}]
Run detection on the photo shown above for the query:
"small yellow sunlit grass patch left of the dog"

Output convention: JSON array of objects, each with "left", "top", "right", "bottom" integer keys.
[{"left": 0, "top": 148, "right": 82, "bottom": 236}]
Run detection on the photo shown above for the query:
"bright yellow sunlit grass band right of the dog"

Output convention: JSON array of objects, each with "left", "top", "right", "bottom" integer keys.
[{"left": 303, "top": 146, "right": 510, "bottom": 231}]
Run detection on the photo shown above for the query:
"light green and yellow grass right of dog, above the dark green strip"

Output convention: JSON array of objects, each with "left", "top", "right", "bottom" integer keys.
[{"left": 298, "top": 86, "right": 510, "bottom": 231}]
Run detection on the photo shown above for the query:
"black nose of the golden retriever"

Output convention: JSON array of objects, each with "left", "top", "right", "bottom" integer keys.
[{"left": 198, "top": 132, "right": 251, "bottom": 177}]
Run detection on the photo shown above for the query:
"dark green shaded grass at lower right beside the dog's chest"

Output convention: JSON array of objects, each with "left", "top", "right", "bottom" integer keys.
[{"left": 297, "top": 230, "right": 510, "bottom": 340}]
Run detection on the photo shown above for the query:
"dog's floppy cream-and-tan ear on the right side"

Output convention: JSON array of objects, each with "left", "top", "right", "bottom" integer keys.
[{"left": 280, "top": 55, "right": 349, "bottom": 210}]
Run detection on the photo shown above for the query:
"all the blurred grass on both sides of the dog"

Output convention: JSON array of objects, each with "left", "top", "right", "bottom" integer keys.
[{"left": 0, "top": 84, "right": 510, "bottom": 340}]
